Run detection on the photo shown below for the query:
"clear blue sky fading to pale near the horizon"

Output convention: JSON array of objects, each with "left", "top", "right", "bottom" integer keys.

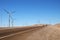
[{"left": 0, "top": 0, "right": 60, "bottom": 27}]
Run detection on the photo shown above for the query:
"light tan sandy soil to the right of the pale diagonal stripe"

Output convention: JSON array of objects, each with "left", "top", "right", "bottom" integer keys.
[{"left": 3, "top": 26, "right": 60, "bottom": 40}]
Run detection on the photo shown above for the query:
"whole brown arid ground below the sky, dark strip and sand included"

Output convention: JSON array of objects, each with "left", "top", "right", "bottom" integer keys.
[{"left": 0, "top": 24, "right": 60, "bottom": 40}]
